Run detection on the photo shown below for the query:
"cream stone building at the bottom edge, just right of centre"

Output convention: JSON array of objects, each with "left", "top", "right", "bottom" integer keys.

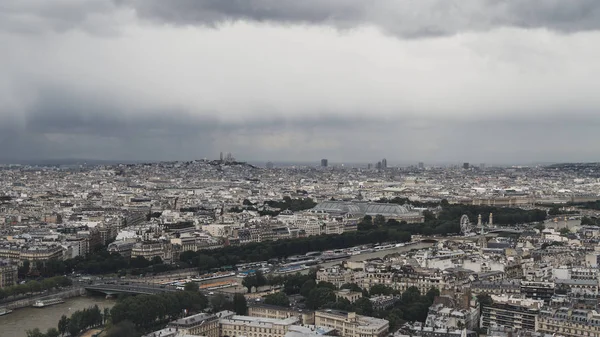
[{"left": 315, "top": 309, "right": 390, "bottom": 337}]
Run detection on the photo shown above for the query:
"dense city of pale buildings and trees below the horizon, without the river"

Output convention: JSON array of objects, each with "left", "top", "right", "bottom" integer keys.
[{"left": 0, "top": 159, "right": 600, "bottom": 337}]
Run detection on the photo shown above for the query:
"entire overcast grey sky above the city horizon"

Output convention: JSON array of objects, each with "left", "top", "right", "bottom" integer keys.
[{"left": 0, "top": 0, "right": 600, "bottom": 163}]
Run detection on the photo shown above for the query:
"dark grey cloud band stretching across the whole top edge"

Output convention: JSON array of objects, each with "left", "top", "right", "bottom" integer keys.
[{"left": 0, "top": 0, "right": 600, "bottom": 38}]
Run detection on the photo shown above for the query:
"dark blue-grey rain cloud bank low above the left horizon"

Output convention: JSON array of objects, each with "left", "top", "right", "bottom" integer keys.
[{"left": 0, "top": 88, "right": 384, "bottom": 161}]
